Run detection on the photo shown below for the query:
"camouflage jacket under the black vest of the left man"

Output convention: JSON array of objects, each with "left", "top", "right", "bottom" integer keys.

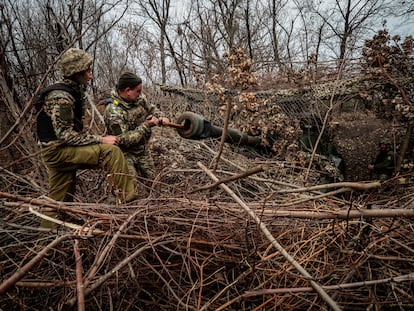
[{"left": 43, "top": 79, "right": 102, "bottom": 146}]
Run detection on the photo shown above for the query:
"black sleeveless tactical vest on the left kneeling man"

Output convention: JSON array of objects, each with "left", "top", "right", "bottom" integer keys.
[{"left": 35, "top": 83, "right": 83, "bottom": 142}]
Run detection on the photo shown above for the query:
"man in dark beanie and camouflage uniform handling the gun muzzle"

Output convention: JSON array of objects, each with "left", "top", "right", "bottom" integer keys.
[{"left": 104, "top": 72, "right": 169, "bottom": 180}]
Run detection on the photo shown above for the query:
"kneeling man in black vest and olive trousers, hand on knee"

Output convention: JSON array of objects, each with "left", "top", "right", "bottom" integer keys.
[{"left": 37, "top": 48, "right": 137, "bottom": 226}]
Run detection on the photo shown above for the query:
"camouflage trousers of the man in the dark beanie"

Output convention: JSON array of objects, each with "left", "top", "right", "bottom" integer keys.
[{"left": 124, "top": 149, "right": 156, "bottom": 181}]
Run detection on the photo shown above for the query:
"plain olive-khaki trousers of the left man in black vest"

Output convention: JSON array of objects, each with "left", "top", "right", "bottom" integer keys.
[{"left": 41, "top": 144, "right": 137, "bottom": 227}]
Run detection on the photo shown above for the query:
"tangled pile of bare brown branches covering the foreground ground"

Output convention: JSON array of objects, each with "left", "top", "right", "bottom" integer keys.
[{"left": 0, "top": 133, "right": 414, "bottom": 310}]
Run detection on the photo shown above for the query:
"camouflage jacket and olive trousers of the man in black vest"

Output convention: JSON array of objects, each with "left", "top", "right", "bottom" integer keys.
[{"left": 41, "top": 80, "right": 135, "bottom": 212}]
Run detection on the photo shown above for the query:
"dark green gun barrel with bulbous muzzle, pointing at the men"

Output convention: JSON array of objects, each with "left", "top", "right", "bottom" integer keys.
[{"left": 165, "top": 111, "right": 261, "bottom": 147}]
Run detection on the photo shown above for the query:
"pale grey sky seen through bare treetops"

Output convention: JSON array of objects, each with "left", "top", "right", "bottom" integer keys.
[{"left": 0, "top": 0, "right": 414, "bottom": 89}]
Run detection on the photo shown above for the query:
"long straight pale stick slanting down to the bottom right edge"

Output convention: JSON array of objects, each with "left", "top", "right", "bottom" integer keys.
[{"left": 197, "top": 162, "right": 341, "bottom": 311}]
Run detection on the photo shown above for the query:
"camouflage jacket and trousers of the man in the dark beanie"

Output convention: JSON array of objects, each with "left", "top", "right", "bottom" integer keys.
[{"left": 104, "top": 90, "right": 160, "bottom": 179}]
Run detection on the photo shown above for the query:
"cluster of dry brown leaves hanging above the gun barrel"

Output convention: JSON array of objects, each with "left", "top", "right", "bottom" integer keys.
[{"left": 206, "top": 49, "right": 301, "bottom": 158}]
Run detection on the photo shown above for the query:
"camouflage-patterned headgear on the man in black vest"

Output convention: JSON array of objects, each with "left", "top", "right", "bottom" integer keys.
[{"left": 58, "top": 48, "right": 92, "bottom": 77}]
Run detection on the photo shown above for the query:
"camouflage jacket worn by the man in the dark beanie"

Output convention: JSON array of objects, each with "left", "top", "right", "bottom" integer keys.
[{"left": 104, "top": 90, "right": 160, "bottom": 151}]
